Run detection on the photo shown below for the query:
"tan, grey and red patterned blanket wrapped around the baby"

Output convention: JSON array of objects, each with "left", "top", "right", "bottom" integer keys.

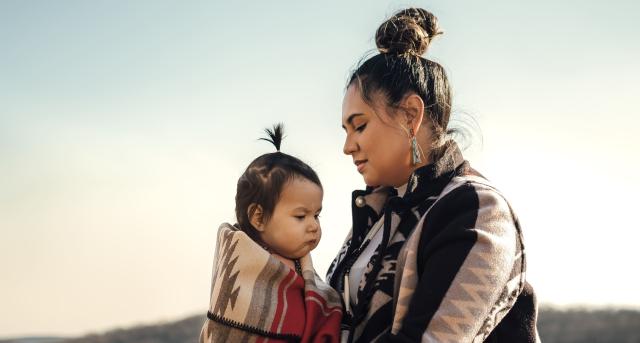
[{"left": 200, "top": 223, "right": 342, "bottom": 342}]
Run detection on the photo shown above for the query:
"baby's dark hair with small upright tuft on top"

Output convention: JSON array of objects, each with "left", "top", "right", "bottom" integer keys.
[{"left": 236, "top": 124, "right": 322, "bottom": 243}]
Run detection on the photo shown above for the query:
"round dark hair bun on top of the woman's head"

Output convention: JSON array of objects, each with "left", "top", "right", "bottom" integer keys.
[{"left": 376, "top": 7, "right": 443, "bottom": 56}]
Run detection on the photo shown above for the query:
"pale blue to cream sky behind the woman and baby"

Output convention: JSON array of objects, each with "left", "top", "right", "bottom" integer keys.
[{"left": 0, "top": 0, "right": 640, "bottom": 338}]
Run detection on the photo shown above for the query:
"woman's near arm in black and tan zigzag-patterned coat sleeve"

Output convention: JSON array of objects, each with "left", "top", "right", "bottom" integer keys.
[{"left": 388, "top": 184, "right": 524, "bottom": 343}]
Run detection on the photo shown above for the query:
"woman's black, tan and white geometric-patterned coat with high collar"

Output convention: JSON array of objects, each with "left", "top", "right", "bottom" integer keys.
[{"left": 327, "top": 141, "right": 537, "bottom": 343}]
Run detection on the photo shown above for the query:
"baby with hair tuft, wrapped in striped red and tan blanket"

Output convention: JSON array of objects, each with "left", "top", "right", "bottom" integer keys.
[{"left": 200, "top": 124, "right": 342, "bottom": 342}]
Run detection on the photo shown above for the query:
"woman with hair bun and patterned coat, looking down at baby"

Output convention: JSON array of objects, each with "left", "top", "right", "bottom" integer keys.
[{"left": 327, "top": 8, "right": 538, "bottom": 343}]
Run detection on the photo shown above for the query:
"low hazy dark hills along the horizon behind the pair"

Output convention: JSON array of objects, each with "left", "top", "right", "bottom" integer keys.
[{"left": 5, "top": 307, "right": 640, "bottom": 343}]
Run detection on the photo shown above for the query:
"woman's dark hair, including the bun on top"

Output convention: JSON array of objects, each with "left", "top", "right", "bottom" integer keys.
[{"left": 347, "top": 8, "right": 451, "bottom": 155}]
